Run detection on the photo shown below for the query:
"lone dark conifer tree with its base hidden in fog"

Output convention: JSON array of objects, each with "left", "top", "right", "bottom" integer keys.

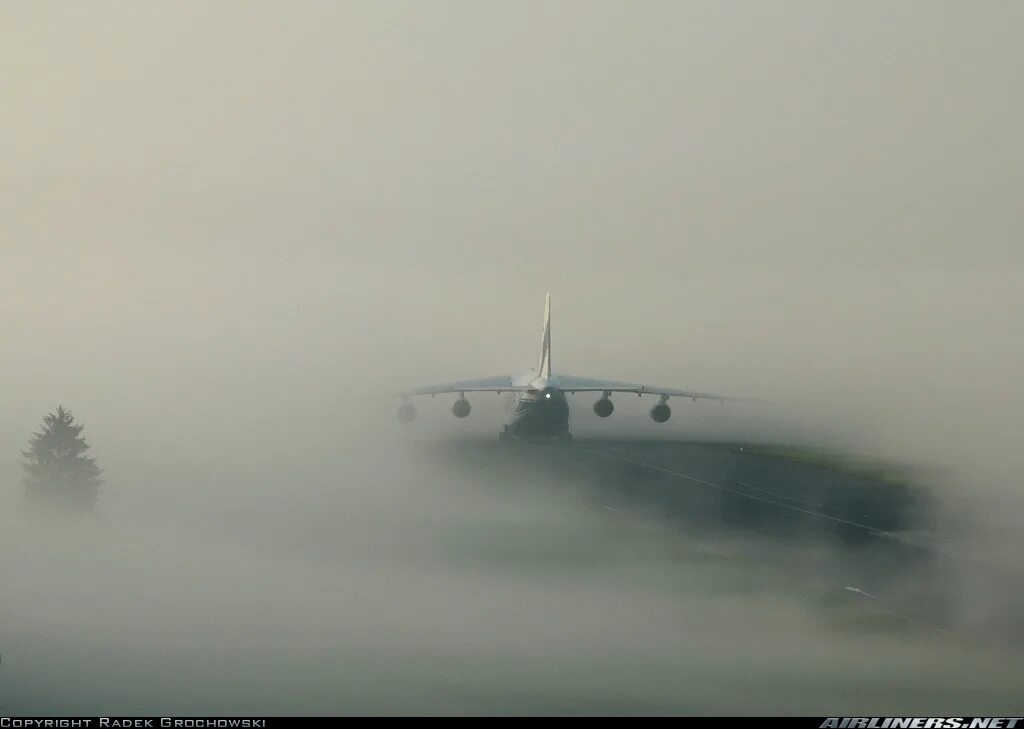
[{"left": 22, "top": 405, "right": 102, "bottom": 511}]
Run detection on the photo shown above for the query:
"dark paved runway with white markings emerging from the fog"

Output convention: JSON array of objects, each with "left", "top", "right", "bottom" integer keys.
[{"left": 430, "top": 439, "right": 1024, "bottom": 642}]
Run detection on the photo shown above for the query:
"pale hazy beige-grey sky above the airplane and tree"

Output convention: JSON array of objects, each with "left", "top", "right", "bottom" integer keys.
[{"left": 0, "top": 2, "right": 1024, "bottom": 487}]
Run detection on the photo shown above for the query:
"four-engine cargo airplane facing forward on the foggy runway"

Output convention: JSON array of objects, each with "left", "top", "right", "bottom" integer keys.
[{"left": 398, "top": 294, "right": 737, "bottom": 441}]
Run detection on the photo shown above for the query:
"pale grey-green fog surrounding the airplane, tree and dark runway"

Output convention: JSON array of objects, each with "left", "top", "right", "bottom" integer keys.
[{"left": 0, "top": 1, "right": 1024, "bottom": 715}]
